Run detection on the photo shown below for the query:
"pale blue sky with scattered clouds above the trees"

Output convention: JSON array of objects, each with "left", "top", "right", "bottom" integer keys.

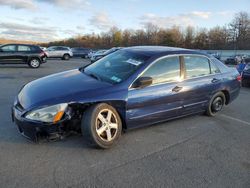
[{"left": 0, "top": 0, "right": 250, "bottom": 42}]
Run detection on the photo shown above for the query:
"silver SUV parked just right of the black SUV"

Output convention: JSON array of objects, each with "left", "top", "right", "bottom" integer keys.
[{"left": 45, "top": 46, "right": 73, "bottom": 60}]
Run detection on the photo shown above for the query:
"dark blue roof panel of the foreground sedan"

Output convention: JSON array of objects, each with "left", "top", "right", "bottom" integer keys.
[{"left": 124, "top": 46, "right": 209, "bottom": 57}]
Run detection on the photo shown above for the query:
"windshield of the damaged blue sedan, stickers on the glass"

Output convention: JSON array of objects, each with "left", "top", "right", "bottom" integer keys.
[{"left": 83, "top": 50, "right": 149, "bottom": 84}]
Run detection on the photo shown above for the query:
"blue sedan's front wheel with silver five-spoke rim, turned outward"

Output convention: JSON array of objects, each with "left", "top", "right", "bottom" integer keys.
[{"left": 81, "top": 103, "right": 122, "bottom": 149}]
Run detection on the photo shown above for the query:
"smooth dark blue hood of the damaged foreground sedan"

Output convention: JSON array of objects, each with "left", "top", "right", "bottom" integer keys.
[{"left": 18, "top": 69, "right": 112, "bottom": 110}]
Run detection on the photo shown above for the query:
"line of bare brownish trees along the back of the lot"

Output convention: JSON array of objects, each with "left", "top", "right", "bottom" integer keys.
[{"left": 41, "top": 12, "right": 250, "bottom": 50}]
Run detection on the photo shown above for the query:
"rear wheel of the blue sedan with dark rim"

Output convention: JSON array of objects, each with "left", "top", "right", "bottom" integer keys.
[{"left": 206, "top": 92, "right": 226, "bottom": 116}]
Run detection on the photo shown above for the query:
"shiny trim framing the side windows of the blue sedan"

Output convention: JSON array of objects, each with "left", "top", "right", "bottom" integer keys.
[{"left": 128, "top": 54, "right": 221, "bottom": 91}]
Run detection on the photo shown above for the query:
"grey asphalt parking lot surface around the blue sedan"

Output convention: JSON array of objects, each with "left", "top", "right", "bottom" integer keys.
[{"left": 0, "top": 59, "right": 250, "bottom": 188}]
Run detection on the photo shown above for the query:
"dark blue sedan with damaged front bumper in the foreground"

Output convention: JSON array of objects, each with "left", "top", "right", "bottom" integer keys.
[{"left": 12, "top": 46, "right": 241, "bottom": 148}]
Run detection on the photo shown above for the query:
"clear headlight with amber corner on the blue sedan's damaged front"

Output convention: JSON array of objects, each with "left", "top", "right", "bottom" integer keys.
[{"left": 25, "top": 103, "right": 68, "bottom": 123}]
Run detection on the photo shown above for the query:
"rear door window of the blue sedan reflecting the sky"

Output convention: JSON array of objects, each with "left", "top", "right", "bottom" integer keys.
[{"left": 184, "top": 56, "right": 210, "bottom": 78}]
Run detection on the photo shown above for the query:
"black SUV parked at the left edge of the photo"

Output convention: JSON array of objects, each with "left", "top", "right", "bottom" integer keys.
[{"left": 0, "top": 44, "right": 46, "bottom": 68}]
